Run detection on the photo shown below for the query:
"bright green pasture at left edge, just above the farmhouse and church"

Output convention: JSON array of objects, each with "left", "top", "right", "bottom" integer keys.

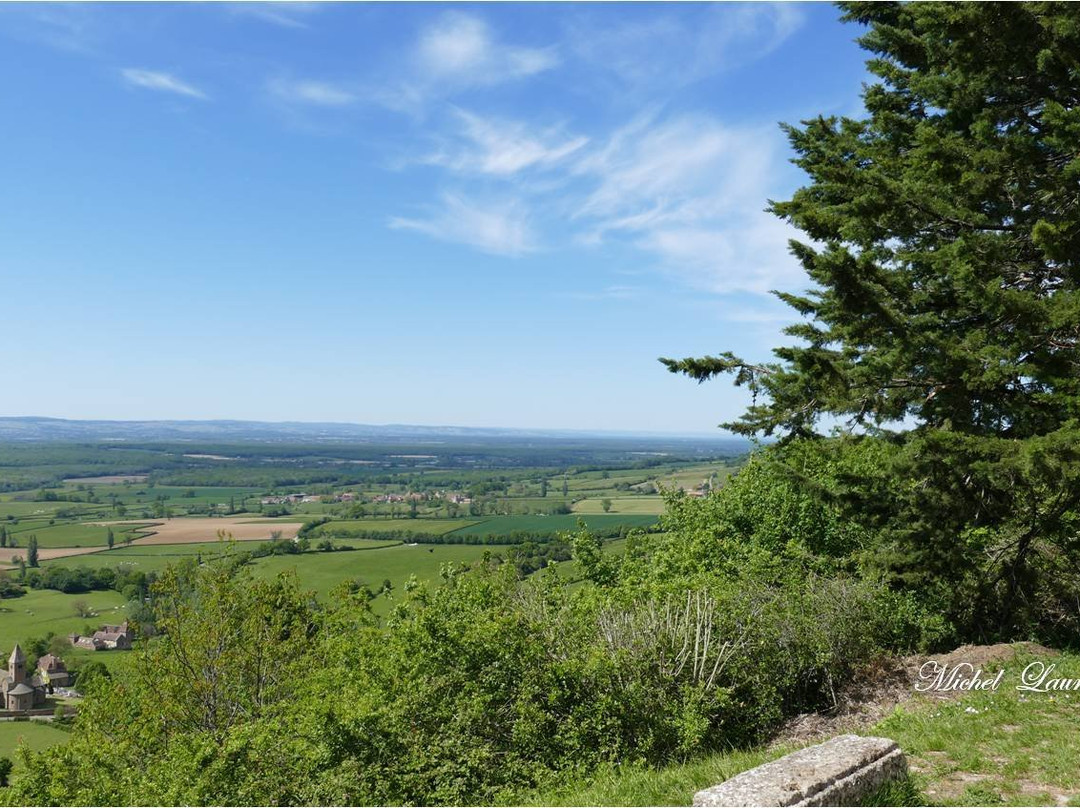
[{"left": 0, "top": 589, "right": 124, "bottom": 659}]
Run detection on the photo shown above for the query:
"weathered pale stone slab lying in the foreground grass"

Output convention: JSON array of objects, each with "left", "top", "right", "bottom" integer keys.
[{"left": 693, "top": 735, "right": 907, "bottom": 807}]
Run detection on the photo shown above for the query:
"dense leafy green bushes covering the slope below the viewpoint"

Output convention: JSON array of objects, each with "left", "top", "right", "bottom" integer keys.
[{"left": 9, "top": 467, "right": 937, "bottom": 804}]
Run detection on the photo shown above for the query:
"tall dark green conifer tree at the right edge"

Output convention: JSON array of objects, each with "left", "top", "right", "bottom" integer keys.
[{"left": 662, "top": 2, "right": 1080, "bottom": 635}]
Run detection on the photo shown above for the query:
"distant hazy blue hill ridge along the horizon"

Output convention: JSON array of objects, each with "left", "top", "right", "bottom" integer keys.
[{"left": 0, "top": 416, "right": 748, "bottom": 452}]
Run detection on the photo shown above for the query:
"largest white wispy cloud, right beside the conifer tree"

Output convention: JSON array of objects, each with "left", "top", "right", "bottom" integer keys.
[{"left": 572, "top": 116, "right": 801, "bottom": 293}]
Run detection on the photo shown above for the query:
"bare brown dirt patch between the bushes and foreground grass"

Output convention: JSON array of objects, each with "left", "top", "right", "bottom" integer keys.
[{"left": 772, "top": 643, "right": 1057, "bottom": 745}]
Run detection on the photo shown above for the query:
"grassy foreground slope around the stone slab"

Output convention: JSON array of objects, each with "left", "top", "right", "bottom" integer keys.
[{"left": 521, "top": 654, "right": 1080, "bottom": 806}]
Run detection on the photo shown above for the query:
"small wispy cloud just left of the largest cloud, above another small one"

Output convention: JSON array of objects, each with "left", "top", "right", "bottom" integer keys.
[{"left": 421, "top": 109, "right": 589, "bottom": 176}]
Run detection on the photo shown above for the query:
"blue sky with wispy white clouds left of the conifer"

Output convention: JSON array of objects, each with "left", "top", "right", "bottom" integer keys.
[{"left": 0, "top": 3, "right": 865, "bottom": 433}]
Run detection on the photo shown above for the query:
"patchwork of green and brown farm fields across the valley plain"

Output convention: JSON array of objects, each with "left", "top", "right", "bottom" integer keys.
[{"left": 0, "top": 442, "right": 743, "bottom": 695}]
